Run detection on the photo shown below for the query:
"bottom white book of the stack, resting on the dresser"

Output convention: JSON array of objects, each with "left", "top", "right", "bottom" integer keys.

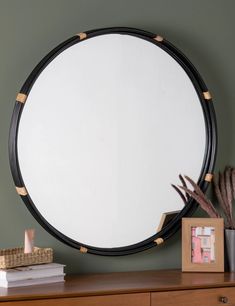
[{"left": 0, "top": 275, "right": 64, "bottom": 288}]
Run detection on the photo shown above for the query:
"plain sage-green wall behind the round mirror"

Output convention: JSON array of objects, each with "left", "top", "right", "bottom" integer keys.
[{"left": 0, "top": 0, "right": 235, "bottom": 273}]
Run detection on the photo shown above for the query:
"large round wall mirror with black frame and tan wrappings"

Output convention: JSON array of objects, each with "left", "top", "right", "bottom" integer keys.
[{"left": 9, "top": 28, "right": 216, "bottom": 255}]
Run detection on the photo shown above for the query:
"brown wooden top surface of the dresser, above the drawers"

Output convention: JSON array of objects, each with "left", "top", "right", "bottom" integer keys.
[{"left": 0, "top": 270, "right": 235, "bottom": 301}]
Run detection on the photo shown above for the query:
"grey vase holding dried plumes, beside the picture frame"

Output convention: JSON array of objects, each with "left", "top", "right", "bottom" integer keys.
[{"left": 225, "top": 229, "right": 235, "bottom": 272}]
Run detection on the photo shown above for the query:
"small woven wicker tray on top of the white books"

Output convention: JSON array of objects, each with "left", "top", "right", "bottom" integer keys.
[{"left": 0, "top": 247, "right": 53, "bottom": 269}]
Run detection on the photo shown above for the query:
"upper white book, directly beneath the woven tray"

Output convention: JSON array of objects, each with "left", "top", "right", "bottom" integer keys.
[{"left": 0, "top": 263, "right": 65, "bottom": 282}]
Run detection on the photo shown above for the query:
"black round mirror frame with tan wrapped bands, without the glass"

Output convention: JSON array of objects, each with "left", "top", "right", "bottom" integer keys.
[{"left": 9, "top": 27, "right": 217, "bottom": 256}]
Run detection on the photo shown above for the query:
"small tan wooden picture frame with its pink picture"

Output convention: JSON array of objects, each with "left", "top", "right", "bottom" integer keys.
[{"left": 182, "top": 218, "right": 224, "bottom": 272}]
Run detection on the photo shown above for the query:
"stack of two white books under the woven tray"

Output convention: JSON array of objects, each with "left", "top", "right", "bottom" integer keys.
[{"left": 0, "top": 263, "right": 65, "bottom": 288}]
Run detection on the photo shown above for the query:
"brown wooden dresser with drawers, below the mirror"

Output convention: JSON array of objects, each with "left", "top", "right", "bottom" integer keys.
[{"left": 0, "top": 270, "right": 235, "bottom": 306}]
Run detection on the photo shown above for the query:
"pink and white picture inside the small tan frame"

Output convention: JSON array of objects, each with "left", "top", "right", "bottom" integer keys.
[{"left": 191, "top": 226, "right": 215, "bottom": 263}]
